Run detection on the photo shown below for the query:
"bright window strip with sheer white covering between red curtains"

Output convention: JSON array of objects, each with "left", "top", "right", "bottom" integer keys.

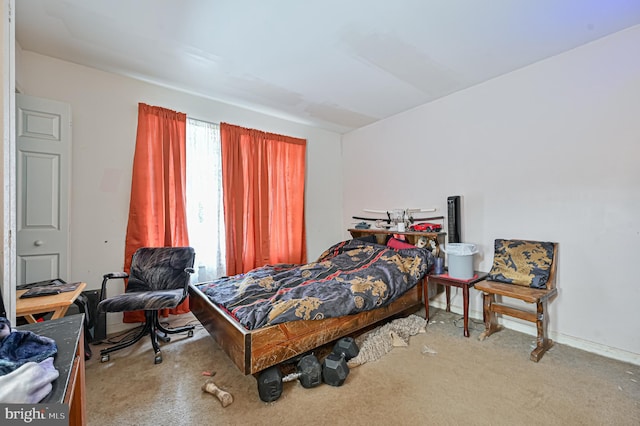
[{"left": 187, "top": 118, "right": 226, "bottom": 282}]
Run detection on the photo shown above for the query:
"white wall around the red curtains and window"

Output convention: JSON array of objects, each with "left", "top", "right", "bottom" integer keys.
[{"left": 17, "top": 49, "right": 343, "bottom": 328}]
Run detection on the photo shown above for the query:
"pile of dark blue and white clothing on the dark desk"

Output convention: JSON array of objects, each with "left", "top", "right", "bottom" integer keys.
[{"left": 0, "top": 317, "right": 59, "bottom": 404}]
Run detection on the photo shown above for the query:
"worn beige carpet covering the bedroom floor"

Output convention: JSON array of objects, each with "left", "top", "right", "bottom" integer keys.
[{"left": 86, "top": 309, "right": 640, "bottom": 426}]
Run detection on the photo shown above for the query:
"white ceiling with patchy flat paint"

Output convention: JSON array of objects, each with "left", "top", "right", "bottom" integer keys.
[{"left": 15, "top": 0, "right": 640, "bottom": 133}]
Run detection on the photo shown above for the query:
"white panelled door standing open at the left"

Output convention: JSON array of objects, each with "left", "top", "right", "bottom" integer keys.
[{"left": 16, "top": 95, "right": 71, "bottom": 284}]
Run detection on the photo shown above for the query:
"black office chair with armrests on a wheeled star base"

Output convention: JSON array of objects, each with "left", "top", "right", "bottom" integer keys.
[{"left": 98, "top": 247, "right": 195, "bottom": 364}]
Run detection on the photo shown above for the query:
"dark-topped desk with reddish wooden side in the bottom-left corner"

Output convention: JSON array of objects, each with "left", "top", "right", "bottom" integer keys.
[{"left": 17, "top": 314, "right": 87, "bottom": 426}]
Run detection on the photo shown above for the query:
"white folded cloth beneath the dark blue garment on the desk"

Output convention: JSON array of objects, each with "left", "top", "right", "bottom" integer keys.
[{"left": 0, "top": 357, "right": 60, "bottom": 404}]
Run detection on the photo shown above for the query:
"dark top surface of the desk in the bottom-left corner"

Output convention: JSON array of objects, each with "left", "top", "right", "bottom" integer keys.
[{"left": 16, "top": 314, "right": 84, "bottom": 404}]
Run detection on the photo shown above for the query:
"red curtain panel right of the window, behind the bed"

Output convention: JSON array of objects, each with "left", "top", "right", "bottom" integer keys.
[{"left": 220, "top": 123, "right": 307, "bottom": 275}]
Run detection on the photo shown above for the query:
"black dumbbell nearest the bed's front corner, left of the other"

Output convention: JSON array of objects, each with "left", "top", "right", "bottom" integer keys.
[{"left": 258, "top": 354, "right": 322, "bottom": 402}]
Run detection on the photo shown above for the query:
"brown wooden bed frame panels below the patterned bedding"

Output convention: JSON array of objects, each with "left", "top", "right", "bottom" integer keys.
[{"left": 189, "top": 279, "right": 426, "bottom": 375}]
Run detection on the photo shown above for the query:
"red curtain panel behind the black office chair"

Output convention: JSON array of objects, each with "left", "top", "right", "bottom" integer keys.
[{"left": 124, "top": 103, "right": 189, "bottom": 322}]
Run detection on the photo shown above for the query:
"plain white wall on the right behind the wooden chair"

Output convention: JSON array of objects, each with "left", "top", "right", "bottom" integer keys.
[{"left": 343, "top": 27, "right": 640, "bottom": 364}]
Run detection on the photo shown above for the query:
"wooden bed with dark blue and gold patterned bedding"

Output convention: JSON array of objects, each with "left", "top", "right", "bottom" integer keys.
[{"left": 189, "top": 239, "right": 433, "bottom": 375}]
